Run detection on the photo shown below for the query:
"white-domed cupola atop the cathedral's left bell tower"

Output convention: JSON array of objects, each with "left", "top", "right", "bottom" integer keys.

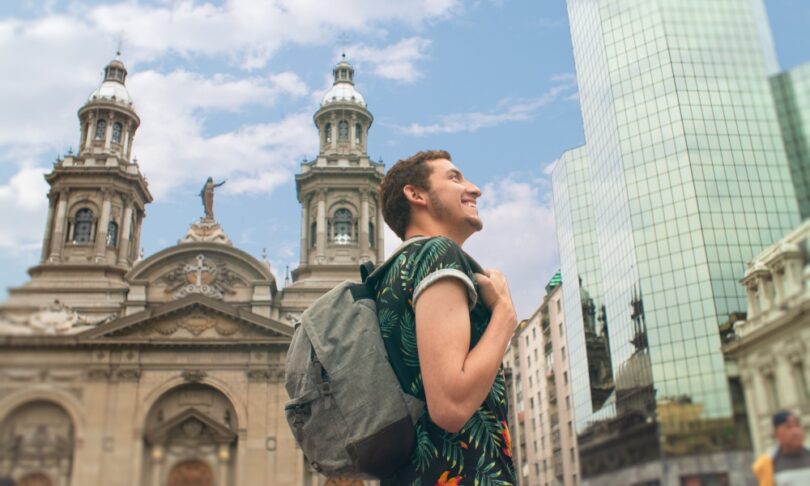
[{"left": 79, "top": 57, "right": 141, "bottom": 161}]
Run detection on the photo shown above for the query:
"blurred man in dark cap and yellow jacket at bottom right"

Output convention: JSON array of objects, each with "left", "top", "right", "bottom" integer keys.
[{"left": 752, "top": 410, "right": 810, "bottom": 486}]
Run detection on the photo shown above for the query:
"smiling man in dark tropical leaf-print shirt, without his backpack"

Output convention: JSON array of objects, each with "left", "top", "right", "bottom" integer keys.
[{"left": 377, "top": 150, "right": 517, "bottom": 486}]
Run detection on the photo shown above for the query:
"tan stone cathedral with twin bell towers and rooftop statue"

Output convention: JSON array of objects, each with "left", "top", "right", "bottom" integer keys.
[{"left": 0, "top": 55, "right": 383, "bottom": 486}]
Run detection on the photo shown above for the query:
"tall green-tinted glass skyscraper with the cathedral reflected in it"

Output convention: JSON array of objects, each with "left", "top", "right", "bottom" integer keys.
[{"left": 553, "top": 0, "right": 799, "bottom": 485}]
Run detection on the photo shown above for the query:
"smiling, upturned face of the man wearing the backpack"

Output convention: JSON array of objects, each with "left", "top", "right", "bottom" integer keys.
[{"left": 427, "top": 159, "right": 484, "bottom": 238}]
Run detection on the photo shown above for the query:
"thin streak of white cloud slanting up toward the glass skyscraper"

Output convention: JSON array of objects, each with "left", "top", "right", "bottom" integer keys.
[{"left": 399, "top": 74, "right": 576, "bottom": 136}]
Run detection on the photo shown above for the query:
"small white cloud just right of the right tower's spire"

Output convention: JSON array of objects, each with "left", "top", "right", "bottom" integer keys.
[{"left": 346, "top": 37, "right": 431, "bottom": 83}]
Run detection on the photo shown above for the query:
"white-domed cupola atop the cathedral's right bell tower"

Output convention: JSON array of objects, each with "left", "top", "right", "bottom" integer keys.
[{"left": 315, "top": 54, "right": 374, "bottom": 157}]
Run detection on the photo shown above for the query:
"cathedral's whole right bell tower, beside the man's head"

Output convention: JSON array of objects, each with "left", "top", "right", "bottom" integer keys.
[{"left": 285, "top": 55, "right": 385, "bottom": 314}]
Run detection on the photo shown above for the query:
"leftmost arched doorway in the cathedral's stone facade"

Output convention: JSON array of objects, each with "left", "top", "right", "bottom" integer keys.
[{"left": 0, "top": 400, "right": 75, "bottom": 486}]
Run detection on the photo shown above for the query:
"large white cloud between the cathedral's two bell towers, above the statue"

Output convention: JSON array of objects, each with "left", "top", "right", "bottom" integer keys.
[{"left": 121, "top": 71, "right": 318, "bottom": 197}]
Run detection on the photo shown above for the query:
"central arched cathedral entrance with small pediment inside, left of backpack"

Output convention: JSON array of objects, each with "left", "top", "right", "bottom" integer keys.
[{"left": 143, "top": 383, "right": 238, "bottom": 486}]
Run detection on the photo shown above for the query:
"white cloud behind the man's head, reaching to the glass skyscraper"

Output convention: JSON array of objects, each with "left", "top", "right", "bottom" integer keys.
[{"left": 385, "top": 172, "right": 559, "bottom": 319}]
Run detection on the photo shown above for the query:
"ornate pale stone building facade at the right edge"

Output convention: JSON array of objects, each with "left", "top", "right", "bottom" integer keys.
[{"left": 724, "top": 221, "right": 810, "bottom": 453}]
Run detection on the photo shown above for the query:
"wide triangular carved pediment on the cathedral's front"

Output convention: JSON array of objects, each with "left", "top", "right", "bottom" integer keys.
[{"left": 80, "top": 294, "right": 293, "bottom": 344}]
